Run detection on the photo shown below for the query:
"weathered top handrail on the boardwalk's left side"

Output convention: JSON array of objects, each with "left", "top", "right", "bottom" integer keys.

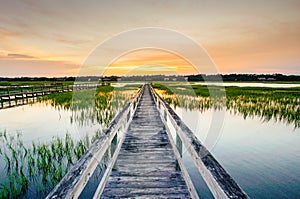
[{"left": 46, "top": 86, "right": 144, "bottom": 199}]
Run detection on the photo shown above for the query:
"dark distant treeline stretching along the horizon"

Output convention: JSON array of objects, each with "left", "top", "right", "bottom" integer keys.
[{"left": 0, "top": 74, "right": 300, "bottom": 82}]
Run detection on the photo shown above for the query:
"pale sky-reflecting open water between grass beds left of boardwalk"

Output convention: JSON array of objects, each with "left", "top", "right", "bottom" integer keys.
[{"left": 0, "top": 103, "right": 101, "bottom": 144}]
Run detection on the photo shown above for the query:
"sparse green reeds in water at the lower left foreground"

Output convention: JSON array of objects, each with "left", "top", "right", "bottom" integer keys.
[{"left": 0, "top": 131, "right": 100, "bottom": 198}]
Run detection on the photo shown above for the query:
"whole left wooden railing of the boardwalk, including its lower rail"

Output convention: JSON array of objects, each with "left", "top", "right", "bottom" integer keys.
[{"left": 46, "top": 84, "right": 144, "bottom": 199}]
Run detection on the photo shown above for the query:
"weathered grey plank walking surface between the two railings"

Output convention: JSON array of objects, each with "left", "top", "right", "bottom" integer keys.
[{"left": 101, "top": 85, "right": 190, "bottom": 198}]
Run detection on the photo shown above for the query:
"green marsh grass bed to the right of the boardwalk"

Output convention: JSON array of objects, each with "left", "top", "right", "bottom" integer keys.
[{"left": 157, "top": 84, "right": 300, "bottom": 128}]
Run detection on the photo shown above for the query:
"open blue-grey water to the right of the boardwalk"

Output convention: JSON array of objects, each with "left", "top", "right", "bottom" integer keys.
[{"left": 176, "top": 108, "right": 300, "bottom": 198}]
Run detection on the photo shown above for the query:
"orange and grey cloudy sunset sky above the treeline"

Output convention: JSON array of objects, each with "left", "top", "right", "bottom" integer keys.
[{"left": 0, "top": 0, "right": 300, "bottom": 77}]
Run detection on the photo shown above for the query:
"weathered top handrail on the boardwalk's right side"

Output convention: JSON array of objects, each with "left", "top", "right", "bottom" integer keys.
[{"left": 151, "top": 85, "right": 249, "bottom": 198}]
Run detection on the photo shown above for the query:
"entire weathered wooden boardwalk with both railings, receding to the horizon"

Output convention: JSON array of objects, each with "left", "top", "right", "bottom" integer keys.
[{"left": 47, "top": 84, "right": 248, "bottom": 198}]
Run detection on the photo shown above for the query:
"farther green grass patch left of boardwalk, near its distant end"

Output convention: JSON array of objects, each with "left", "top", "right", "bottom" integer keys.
[{"left": 40, "top": 85, "right": 137, "bottom": 125}]
